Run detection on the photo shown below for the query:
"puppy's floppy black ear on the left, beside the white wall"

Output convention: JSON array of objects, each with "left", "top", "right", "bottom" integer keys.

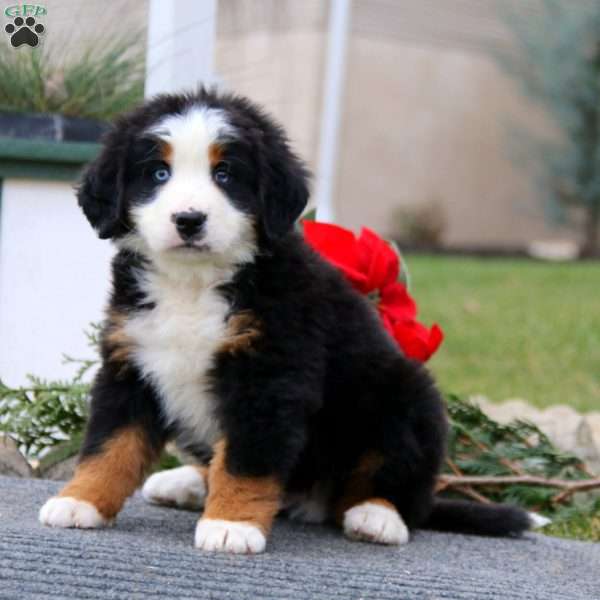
[{"left": 77, "top": 131, "right": 127, "bottom": 240}]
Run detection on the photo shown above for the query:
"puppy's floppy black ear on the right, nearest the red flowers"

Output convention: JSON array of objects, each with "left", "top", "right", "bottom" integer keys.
[{"left": 261, "top": 134, "right": 309, "bottom": 240}]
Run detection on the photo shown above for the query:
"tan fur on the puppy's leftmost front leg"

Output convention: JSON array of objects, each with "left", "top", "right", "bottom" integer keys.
[{"left": 59, "top": 427, "right": 158, "bottom": 519}]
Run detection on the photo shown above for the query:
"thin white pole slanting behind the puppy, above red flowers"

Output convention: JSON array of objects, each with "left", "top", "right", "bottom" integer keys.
[{"left": 315, "top": 0, "right": 351, "bottom": 222}]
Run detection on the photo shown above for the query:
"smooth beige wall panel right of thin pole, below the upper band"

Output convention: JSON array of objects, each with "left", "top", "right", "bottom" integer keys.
[{"left": 336, "top": 36, "right": 573, "bottom": 246}]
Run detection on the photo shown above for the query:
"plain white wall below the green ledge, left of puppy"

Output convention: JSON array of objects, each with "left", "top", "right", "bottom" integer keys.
[{"left": 0, "top": 179, "right": 114, "bottom": 386}]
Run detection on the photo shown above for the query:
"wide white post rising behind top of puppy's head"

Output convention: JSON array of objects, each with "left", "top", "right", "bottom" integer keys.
[{"left": 145, "top": 0, "right": 217, "bottom": 97}]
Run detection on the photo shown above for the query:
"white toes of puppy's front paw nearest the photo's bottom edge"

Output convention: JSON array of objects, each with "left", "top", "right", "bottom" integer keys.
[{"left": 194, "top": 519, "right": 267, "bottom": 554}]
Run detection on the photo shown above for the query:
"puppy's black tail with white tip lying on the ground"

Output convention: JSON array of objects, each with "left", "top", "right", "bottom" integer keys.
[{"left": 422, "top": 498, "right": 550, "bottom": 536}]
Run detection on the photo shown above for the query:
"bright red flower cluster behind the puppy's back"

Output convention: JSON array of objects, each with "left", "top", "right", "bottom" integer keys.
[{"left": 303, "top": 221, "right": 444, "bottom": 362}]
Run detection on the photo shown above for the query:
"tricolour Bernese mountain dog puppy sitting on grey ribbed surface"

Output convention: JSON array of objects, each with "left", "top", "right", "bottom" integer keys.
[{"left": 40, "top": 89, "right": 532, "bottom": 553}]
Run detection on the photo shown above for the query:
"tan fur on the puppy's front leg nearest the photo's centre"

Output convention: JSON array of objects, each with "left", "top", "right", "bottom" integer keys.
[{"left": 202, "top": 441, "right": 282, "bottom": 534}]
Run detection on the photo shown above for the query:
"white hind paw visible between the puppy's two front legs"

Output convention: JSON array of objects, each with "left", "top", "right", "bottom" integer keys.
[{"left": 142, "top": 465, "right": 206, "bottom": 509}]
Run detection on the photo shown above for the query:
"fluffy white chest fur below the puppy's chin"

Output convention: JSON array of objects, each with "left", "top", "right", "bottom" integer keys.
[{"left": 126, "top": 273, "right": 228, "bottom": 444}]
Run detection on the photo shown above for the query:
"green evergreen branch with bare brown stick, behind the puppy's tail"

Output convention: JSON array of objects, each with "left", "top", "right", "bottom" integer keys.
[{"left": 438, "top": 396, "right": 600, "bottom": 520}]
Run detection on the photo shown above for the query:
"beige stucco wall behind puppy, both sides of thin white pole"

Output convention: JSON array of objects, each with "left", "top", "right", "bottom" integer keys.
[{"left": 217, "top": 0, "right": 575, "bottom": 247}]
